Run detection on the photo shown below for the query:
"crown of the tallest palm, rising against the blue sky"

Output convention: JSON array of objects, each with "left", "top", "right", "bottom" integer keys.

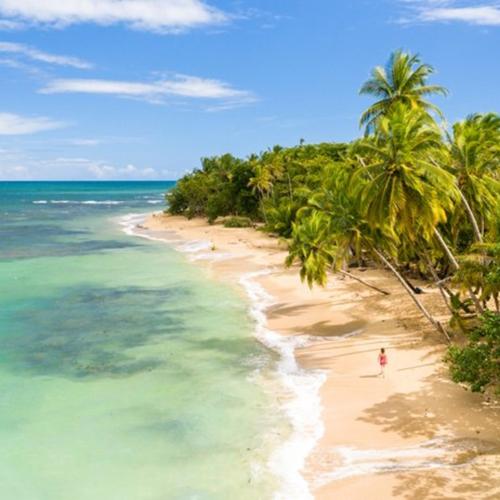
[{"left": 359, "top": 50, "right": 448, "bottom": 134}]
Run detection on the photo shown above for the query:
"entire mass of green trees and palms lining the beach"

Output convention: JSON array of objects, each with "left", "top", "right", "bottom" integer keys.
[{"left": 167, "top": 51, "right": 500, "bottom": 390}]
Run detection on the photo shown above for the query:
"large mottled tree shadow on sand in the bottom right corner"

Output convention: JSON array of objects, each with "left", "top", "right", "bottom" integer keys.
[{"left": 359, "top": 367, "right": 500, "bottom": 500}]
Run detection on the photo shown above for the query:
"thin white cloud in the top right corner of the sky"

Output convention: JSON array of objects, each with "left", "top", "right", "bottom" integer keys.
[{"left": 403, "top": 0, "right": 500, "bottom": 26}]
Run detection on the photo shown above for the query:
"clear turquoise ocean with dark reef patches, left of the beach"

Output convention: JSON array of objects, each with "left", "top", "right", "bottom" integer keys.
[{"left": 0, "top": 182, "right": 296, "bottom": 500}]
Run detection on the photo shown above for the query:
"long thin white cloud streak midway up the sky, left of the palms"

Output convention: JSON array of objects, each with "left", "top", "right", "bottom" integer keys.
[{"left": 40, "top": 75, "right": 255, "bottom": 103}]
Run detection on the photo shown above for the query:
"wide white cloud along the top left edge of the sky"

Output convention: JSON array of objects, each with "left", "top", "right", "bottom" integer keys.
[{"left": 0, "top": 0, "right": 228, "bottom": 32}]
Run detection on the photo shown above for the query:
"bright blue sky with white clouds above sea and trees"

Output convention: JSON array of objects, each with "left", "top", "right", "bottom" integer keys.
[{"left": 0, "top": 0, "right": 500, "bottom": 180}]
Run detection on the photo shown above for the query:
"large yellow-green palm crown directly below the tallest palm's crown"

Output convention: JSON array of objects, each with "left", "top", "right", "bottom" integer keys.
[{"left": 351, "top": 104, "right": 458, "bottom": 241}]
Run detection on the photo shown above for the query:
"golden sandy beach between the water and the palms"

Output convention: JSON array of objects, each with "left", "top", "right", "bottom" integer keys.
[{"left": 143, "top": 214, "right": 500, "bottom": 499}]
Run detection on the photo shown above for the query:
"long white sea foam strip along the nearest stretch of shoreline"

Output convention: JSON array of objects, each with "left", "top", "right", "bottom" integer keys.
[{"left": 240, "top": 271, "right": 326, "bottom": 500}]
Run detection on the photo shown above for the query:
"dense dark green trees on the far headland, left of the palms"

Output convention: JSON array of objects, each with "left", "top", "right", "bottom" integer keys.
[{"left": 167, "top": 144, "right": 346, "bottom": 227}]
